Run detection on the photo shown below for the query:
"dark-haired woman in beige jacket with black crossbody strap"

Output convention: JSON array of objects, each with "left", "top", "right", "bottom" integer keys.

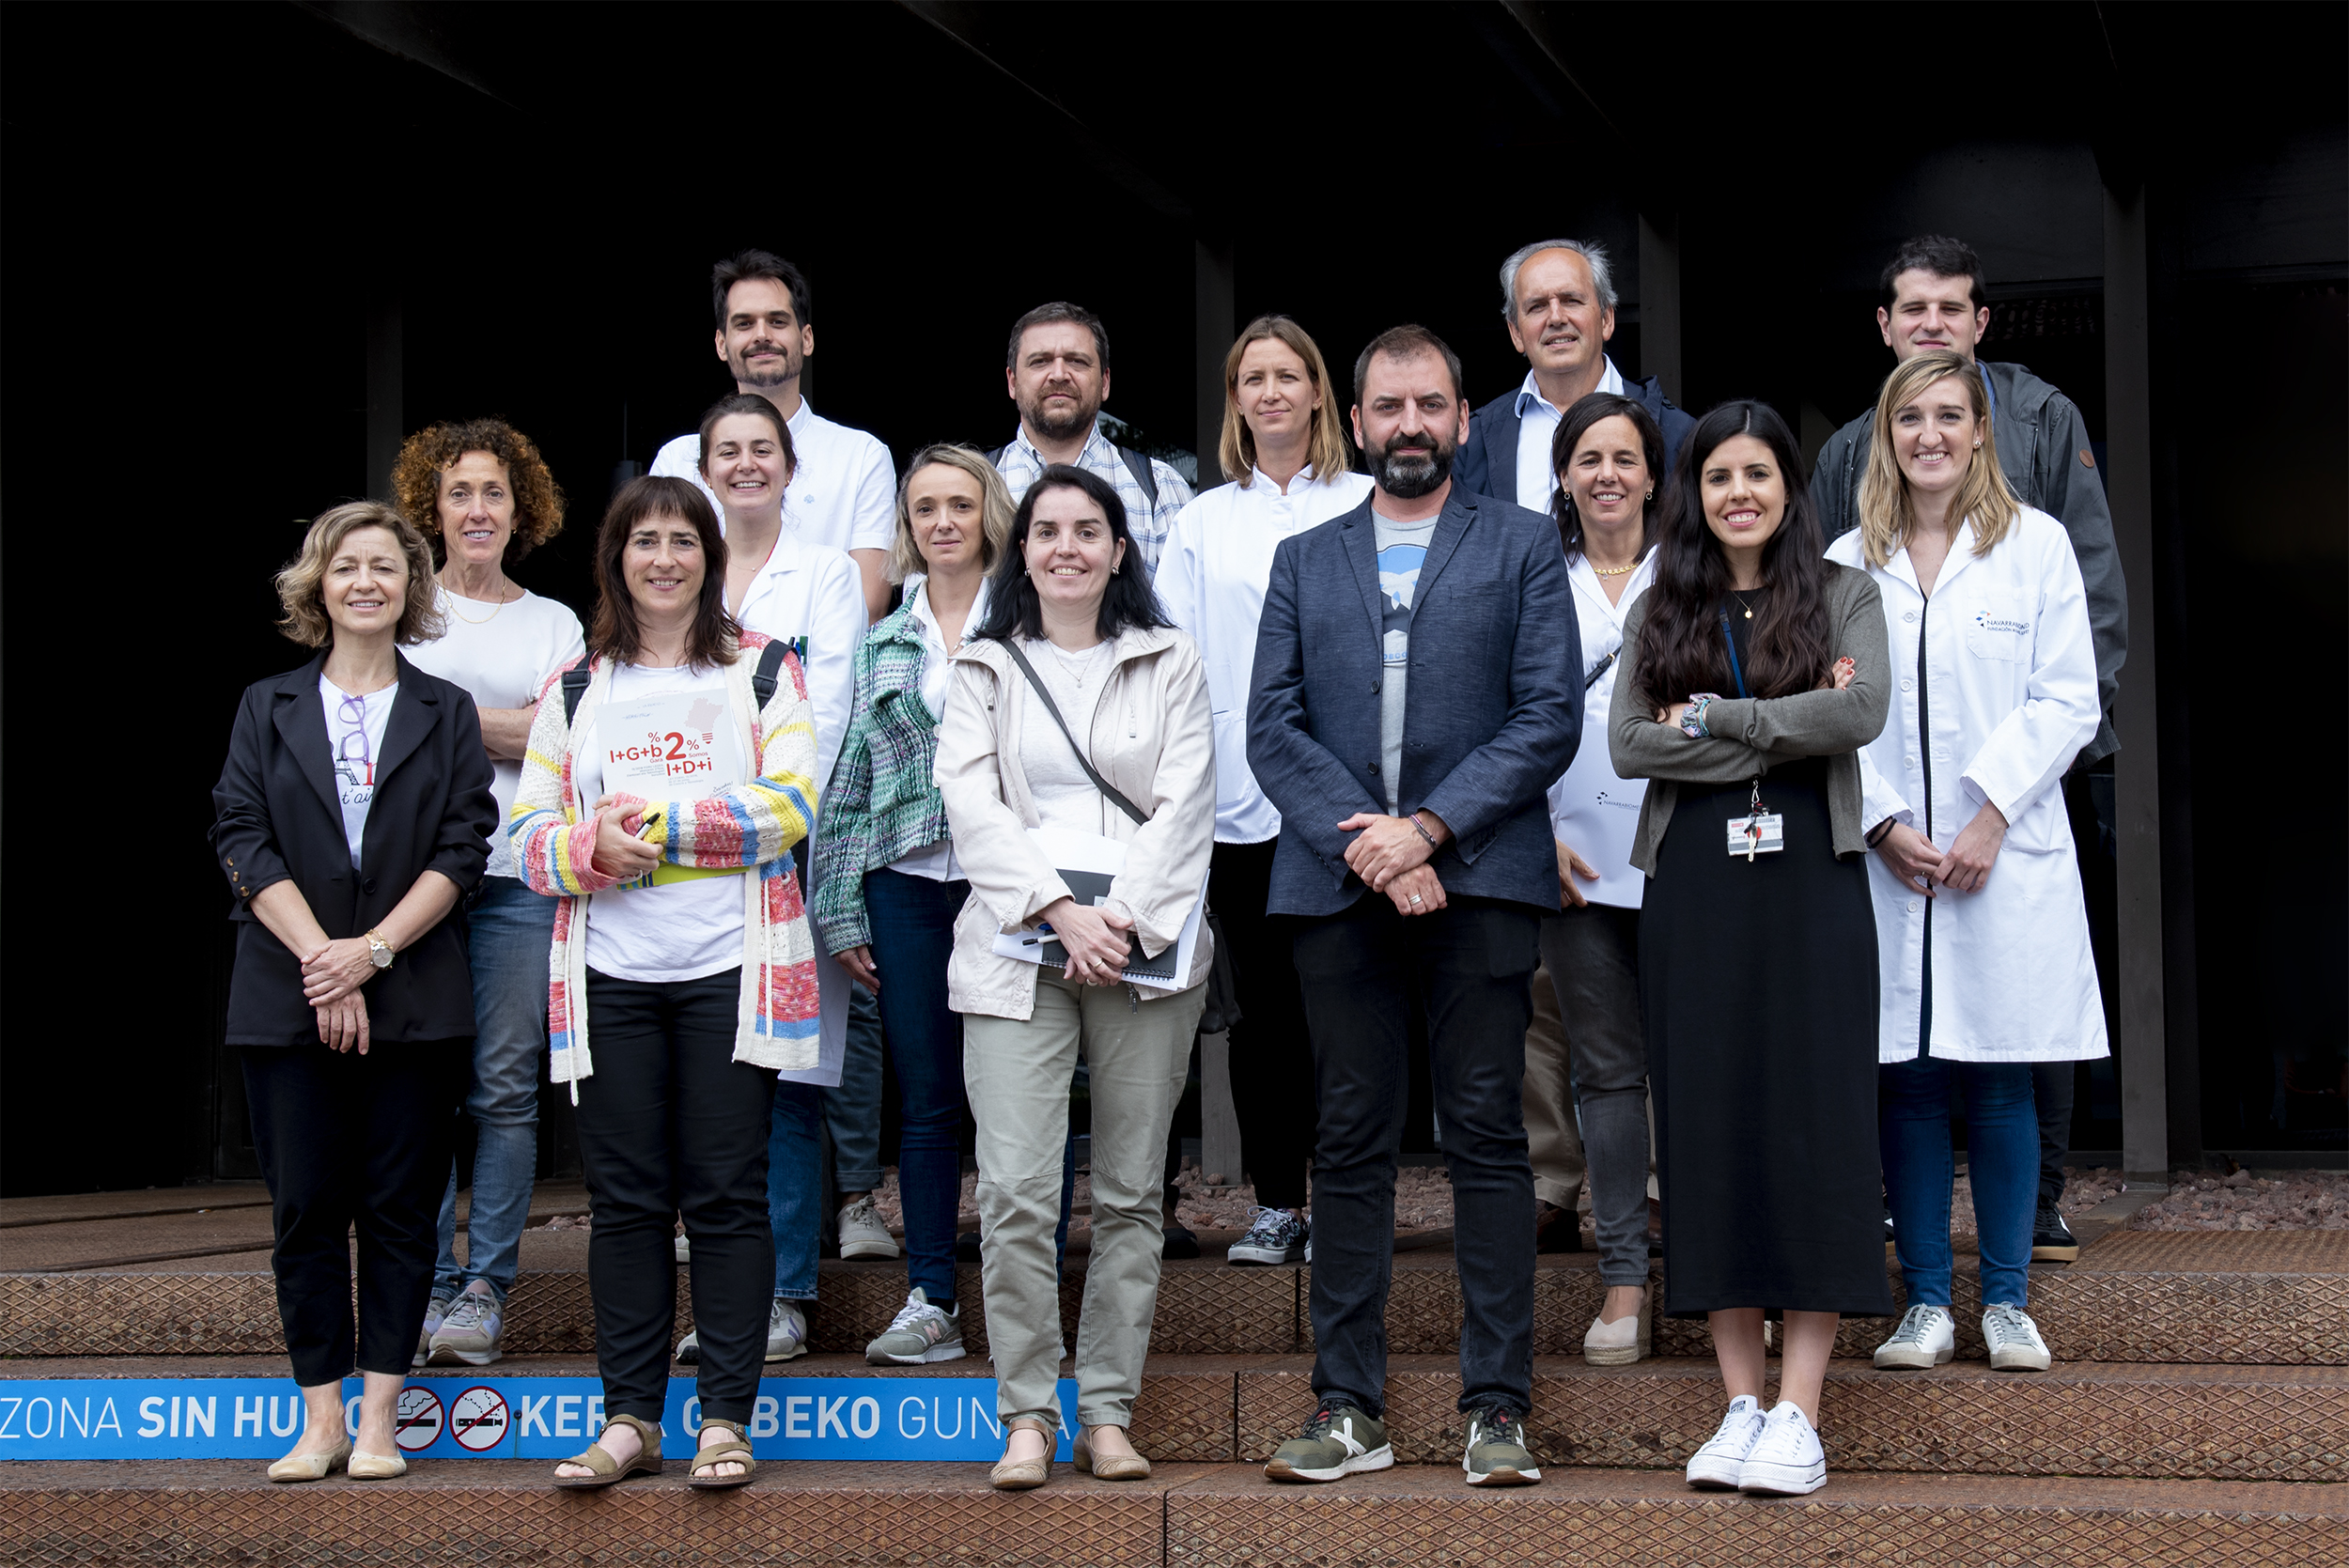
[{"left": 938, "top": 465, "right": 1215, "bottom": 1491}]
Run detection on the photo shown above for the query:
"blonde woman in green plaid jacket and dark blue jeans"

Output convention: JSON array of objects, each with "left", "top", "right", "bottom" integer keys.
[{"left": 811, "top": 446, "right": 1013, "bottom": 1366}]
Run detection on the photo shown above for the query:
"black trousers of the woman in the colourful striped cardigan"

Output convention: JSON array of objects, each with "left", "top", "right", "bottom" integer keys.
[{"left": 578, "top": 970, "right": 775, "bottom": 1422}]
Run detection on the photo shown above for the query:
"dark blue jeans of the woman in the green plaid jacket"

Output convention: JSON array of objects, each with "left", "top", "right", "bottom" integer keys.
[{"left": 864, "top": 866, "right": 971, "bottom": 1305}]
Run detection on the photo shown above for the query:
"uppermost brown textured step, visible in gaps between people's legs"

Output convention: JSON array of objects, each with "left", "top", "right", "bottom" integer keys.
[{"left": 0, "top": 1230, "right": 2349, "bottom": 1366}]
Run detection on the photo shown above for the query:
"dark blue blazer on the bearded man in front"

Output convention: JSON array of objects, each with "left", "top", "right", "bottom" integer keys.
[{"left": 1248, "top": 484, "right": 1583, "bottom": 915}]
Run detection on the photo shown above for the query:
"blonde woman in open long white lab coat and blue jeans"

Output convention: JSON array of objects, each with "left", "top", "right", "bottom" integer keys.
[{"left": 1828, "top": 349, "right": 2108, "bottom": 1371}]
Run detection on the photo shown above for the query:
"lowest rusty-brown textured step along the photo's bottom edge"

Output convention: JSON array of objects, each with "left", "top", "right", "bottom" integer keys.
[{"left": 0, "top": 1460, "right": 2349, "bottom": 1568}]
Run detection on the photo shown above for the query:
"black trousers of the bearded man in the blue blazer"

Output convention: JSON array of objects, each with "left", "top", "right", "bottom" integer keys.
[{"left": 1297, "top": 892, "right": 1541, "bottom": 1416}]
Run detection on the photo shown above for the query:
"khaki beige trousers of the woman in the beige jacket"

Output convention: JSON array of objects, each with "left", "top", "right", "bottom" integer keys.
[{"left": 963, "top": 970, "right": 1207, "bottom": 1430}]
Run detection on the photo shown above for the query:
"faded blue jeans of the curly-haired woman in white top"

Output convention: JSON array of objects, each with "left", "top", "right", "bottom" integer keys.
[{"left": 432, "top": 876, "right": 554, "bottom": 1305}]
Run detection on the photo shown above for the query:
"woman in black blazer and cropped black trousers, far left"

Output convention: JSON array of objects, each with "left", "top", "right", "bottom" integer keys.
[{"left": 211, "top": 503, "right": 498, "bottom": 1482}]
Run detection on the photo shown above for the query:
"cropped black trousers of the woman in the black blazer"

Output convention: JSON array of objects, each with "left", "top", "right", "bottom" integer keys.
[{"left": 244, "top": 1040, "right": 473, "bottom": 1388}]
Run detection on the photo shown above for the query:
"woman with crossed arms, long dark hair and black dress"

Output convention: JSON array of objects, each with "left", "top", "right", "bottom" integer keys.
[{"left": 1607, "top": 401, "right": 1891, "bottom": 1496}]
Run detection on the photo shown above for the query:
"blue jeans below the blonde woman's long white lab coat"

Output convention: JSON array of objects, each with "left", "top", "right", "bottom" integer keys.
[{"left": 1877, "top": 1056, "right": 2039, "bottom": 1308}]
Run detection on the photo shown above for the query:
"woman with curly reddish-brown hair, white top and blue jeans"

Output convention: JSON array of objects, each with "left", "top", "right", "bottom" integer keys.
[{"left": 393, "top": 420, "right": 587, "bottom": 1366}]
